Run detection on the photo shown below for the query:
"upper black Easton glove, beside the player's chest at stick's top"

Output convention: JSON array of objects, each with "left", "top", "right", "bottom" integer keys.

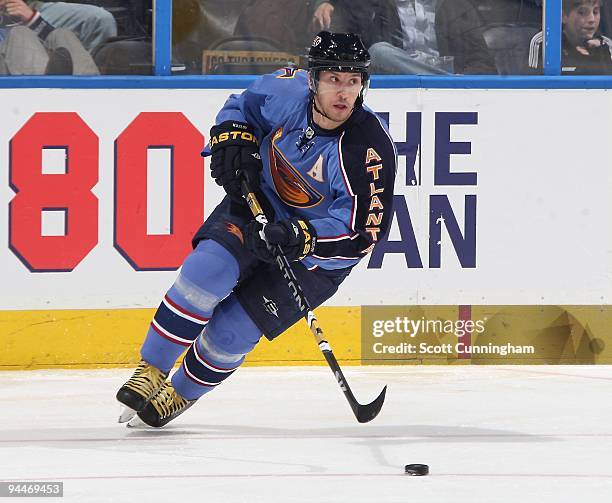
[{"left": 210, "top": 121, "right": 262, "bottom": 200}]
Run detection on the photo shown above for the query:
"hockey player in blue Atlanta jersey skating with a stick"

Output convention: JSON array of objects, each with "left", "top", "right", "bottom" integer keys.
[{"left": 117, "top": 32, "right": 396, "bottom": 427}]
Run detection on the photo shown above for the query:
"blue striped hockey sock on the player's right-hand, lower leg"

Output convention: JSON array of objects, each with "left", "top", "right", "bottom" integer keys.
[{"left": 172, "top": 295, "right": 261, "bottom": 400}]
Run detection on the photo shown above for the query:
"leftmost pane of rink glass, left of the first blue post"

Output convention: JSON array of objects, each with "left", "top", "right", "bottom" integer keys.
[{"left": 0, "top": 0, "right": 154, "bottom": 77}]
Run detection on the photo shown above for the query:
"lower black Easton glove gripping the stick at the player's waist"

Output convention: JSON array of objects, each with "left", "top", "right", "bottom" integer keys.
[{"left": 243, "top": 218, "right": 317, "bottom": 262}]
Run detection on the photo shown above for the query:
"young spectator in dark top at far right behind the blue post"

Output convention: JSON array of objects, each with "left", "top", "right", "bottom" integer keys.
[{"left": 529, "top": 0, "right": 612, "bottom": 75}]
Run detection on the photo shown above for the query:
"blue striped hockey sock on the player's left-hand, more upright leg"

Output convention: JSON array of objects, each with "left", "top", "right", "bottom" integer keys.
[{"left": 140, "top": 240, "right": 239, "bottom": 372}]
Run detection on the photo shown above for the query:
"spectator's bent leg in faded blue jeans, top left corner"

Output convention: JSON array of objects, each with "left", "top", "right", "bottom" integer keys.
[{"left": 10, "top": 0, "right": 117, "bottom": 51}]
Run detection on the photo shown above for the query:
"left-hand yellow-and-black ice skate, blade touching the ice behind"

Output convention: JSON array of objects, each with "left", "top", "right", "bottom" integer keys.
[{"left": 117, "top": 360, "right": 168, "bottom": 423}]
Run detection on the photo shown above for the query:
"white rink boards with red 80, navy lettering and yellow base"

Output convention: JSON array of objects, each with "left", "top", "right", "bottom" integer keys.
[{"left": 0, "top": 89, "right": 612, "bottom": 367}]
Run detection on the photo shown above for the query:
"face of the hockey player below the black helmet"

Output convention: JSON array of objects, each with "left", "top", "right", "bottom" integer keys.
[{"left": 315, "top": 71, "right": 361, "bottom": 129}]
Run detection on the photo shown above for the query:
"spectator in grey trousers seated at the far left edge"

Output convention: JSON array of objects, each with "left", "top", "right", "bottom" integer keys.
[{"left": 0, "top": 0, "right": 99, "bottom": 75}]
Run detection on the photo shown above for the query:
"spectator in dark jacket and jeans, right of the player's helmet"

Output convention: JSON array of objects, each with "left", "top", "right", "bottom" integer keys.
[{"left": 313, "top": 0, "right": 496, "bottom": 74}]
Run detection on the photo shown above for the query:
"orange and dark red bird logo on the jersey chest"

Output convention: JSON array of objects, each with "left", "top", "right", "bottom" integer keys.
[{"left": 270, "top": 128, "right": 323, "bottom": 208}]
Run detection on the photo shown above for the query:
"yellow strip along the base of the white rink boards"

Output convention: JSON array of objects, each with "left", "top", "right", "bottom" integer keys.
[{"left": 0, "top": 305, "right": 612, "bottom": 370}]
